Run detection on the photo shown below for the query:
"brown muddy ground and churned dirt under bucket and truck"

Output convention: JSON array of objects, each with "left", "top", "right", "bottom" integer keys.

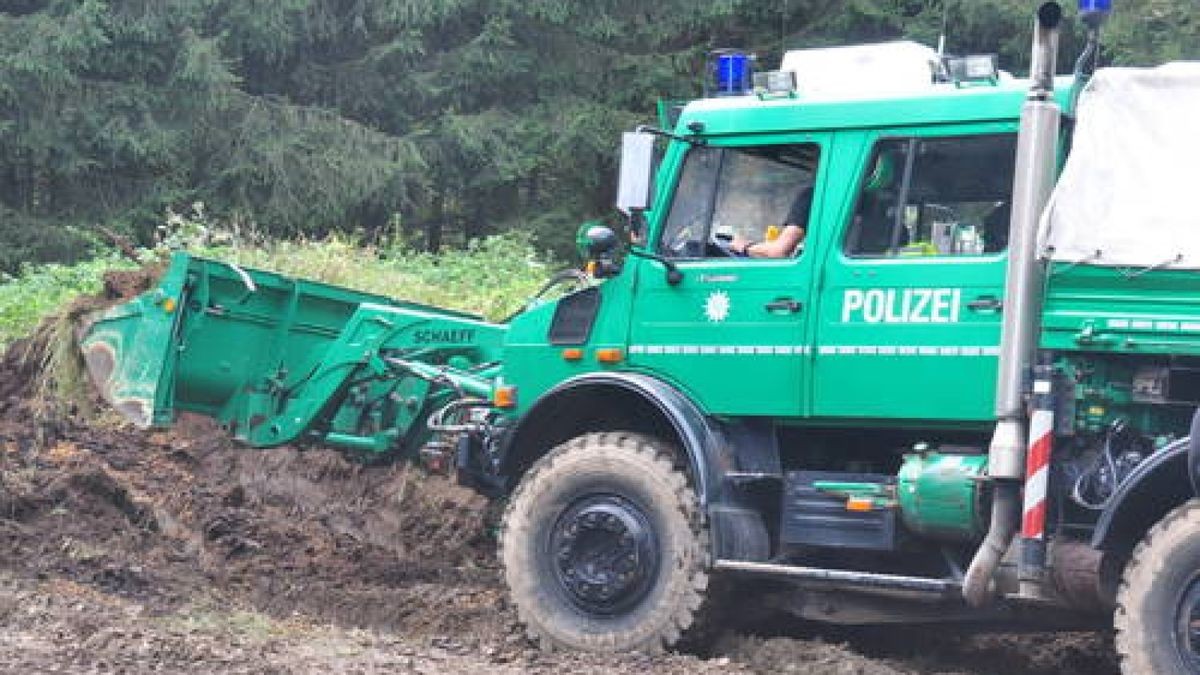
[{"left": 0, "top": 275, "right": 1116, "bottom": 675}]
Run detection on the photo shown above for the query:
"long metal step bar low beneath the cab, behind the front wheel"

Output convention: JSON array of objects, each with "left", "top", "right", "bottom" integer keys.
[{"left": 714, "top": 560, "right": 962, "bottom": 601}]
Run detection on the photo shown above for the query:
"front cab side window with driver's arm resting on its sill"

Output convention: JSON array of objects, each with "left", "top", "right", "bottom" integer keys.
[{"left": 659, "top": 143, "right": 820, "bottom": 259}]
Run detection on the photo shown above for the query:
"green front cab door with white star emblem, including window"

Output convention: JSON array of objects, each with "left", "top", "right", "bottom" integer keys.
[{"left": 629, "top": 135, "right": 827, "bottom": 416}]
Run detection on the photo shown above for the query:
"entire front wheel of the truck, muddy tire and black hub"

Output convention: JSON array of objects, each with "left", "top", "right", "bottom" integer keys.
[{"left": 500, "top": 432, "right": 709, "bottom": 652}]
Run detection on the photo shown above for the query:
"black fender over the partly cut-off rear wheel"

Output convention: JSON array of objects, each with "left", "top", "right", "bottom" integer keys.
[{"left": 1092, "top": 427, "right": 1200, "bottom": 552}]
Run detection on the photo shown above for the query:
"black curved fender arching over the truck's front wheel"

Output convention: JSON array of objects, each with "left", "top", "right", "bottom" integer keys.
[{"left": 499, "top": 371, "right": 725, "bottom": 506}]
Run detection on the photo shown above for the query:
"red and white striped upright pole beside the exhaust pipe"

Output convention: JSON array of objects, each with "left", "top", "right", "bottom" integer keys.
[{"left": 1020, "top": 363, "right": 1054, "bottom": 583}]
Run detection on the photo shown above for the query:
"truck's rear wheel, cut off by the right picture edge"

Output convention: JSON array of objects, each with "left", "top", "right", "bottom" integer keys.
[{"left": 1114, "top": 500, "right": 1200, "bottom": 675}]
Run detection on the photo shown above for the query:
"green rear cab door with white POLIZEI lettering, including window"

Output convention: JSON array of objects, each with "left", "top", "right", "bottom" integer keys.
[{"left": 814, "top": 127, "right": 1016, "bottom": 423}]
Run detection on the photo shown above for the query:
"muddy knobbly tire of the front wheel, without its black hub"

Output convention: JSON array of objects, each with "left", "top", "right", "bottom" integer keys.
[{"left": 500, "top": 432, "right": 709, "bottom": 653}]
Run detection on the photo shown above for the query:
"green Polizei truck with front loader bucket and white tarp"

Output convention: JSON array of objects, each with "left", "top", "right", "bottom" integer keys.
[{"left": 82, "top": 1, "right": 1200, "bottom": 674}]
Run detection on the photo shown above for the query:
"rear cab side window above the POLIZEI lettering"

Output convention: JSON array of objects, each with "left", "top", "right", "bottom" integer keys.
[{"left": 845, "top": 133, "right": 1016, "bottom": 257}]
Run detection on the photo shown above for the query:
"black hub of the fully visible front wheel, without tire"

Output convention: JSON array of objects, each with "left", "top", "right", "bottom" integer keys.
[{"left": 550, "top": 495, "right": 659, "bottom": 615}]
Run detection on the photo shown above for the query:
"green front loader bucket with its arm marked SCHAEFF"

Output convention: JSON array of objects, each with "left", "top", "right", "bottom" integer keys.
[{"left": 82, "top": 253, "right": 505, "bottom": 452}]
